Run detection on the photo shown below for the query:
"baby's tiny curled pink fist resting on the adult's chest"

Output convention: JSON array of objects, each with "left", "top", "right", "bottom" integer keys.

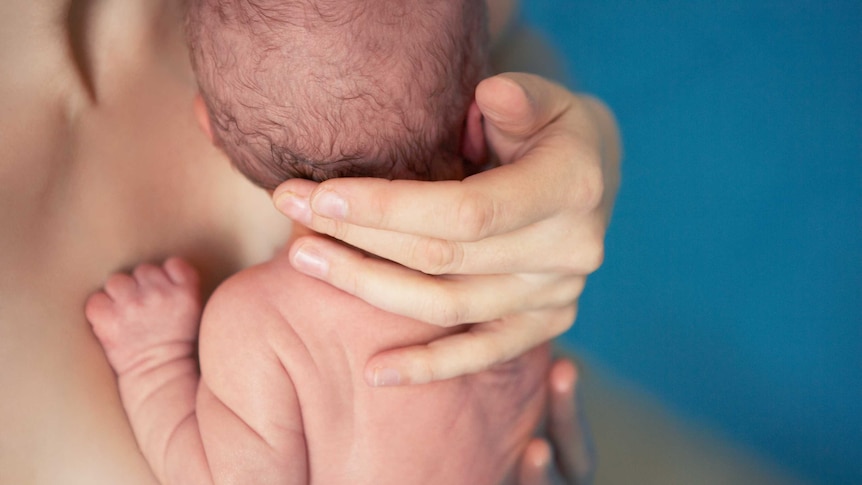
[{"left": 85, "top": 258, "right": 201, "bottom": 376}]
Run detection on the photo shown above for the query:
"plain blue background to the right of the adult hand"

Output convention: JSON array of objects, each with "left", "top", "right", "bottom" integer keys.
[{"left": 523, "top": 0, "right": 862, "bottom": 484}]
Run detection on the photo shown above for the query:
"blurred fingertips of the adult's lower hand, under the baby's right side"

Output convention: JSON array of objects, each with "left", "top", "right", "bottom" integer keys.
[{"left": 518, "top": 359, "right": 595, "bottom": 485}]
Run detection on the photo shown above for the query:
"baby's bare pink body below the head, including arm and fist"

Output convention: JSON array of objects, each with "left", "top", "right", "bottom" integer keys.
[{"left": 87, "top": 232, "right": 549, "bottom": 485}]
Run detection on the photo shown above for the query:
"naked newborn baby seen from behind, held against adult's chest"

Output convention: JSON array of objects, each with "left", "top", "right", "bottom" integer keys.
[{"left": 86, "top": 0, "right": 549, "bottom": 485}]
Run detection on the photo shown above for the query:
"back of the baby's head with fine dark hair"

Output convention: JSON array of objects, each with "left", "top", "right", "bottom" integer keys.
[{"left": 187, "top": 0, "right": 489, "bottom": 190}]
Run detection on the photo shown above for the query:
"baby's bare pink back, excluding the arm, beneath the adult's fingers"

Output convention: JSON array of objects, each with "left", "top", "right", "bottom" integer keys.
[{"left": 262, "top": 253, "right": 550, "bottom": 485}]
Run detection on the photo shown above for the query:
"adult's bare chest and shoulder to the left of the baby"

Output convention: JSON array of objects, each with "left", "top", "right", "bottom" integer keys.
[{"left": 0, "top": 0, "right": 592, "bottom": 485}]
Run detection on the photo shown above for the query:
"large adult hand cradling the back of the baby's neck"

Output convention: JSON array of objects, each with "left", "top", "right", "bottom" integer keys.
[{"left": 274, "top": 73, "right": 619, "bottom": 385}]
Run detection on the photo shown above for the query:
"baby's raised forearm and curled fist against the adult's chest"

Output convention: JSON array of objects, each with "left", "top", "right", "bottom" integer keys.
[{"left": 86, "top": 259, "right": 212, "bottom": 484}]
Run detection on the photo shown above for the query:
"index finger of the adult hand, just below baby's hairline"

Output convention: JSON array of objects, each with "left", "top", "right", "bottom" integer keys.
[{"left": 275, "top": 142, "right": 579, "bottom": 241}]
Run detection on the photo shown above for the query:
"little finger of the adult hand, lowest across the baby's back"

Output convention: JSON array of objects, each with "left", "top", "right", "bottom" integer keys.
[{"left": 365, "top": 305, "right": 576, "bottom": 386}]
